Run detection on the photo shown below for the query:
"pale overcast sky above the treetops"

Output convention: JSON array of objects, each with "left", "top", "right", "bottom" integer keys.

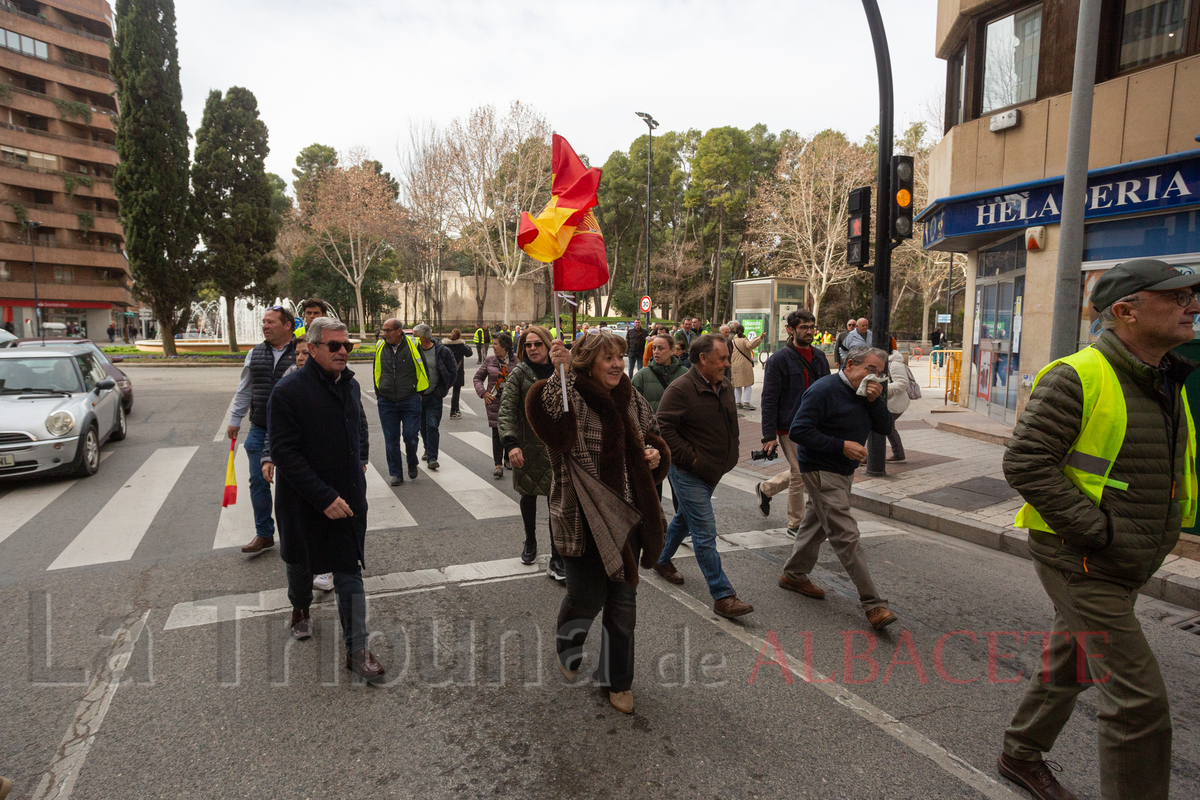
[{"left": 176, "top": 0, "right": 946, "bottom": 194}]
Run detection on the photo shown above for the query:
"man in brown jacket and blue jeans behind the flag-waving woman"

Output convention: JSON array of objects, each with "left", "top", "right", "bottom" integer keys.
[{"left": 654, "top": 333, "right": 754, "bottom": 619}]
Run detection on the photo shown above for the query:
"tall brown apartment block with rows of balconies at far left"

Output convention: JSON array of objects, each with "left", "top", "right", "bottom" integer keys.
[{"left": 0, "top": 0, "right": 134, "bottom": 341}]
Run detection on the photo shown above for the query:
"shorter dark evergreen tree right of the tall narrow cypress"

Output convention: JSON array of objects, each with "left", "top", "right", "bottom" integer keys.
[{"left": 192, "top": 86, "right": 278, "bottom": 353}]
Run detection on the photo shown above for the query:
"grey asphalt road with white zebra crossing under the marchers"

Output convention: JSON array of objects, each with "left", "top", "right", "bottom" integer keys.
[{"left": 0, "top": 367, "right": 1200, "bottom": 800}]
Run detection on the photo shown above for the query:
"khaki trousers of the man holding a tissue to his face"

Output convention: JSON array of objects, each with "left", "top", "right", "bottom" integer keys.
[{"left": 784, "top": 471, "right": 888, "bottom": 610}]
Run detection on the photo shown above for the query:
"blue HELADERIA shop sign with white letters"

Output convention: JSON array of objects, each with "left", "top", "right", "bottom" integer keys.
[{"left": 917, "top": 150, "right": 1200, "bottom": 249}]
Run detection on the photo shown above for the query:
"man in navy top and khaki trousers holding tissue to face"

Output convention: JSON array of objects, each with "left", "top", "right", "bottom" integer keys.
[{"left": 779, "top": 347, "right": 896, "bottom": 630}]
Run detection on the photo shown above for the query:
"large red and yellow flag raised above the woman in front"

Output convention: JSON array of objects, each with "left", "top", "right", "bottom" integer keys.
[{"left": 517, "top": 133, "right": 608, "bottom": 291}]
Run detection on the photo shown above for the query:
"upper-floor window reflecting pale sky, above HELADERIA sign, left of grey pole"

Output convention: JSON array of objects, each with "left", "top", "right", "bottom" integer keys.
[{"left": 983, "top": 4, "right": 1042, "bottom": 114}]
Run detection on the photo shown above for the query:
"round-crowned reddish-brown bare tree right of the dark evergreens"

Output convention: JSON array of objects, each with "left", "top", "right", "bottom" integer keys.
[{"left": 299, "top": 149, "right": 402, "bottom": 333}]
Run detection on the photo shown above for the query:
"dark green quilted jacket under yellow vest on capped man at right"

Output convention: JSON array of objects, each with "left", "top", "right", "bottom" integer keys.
[{"left": 1004, "top": 331, "right": 1195, "bottom": 589}]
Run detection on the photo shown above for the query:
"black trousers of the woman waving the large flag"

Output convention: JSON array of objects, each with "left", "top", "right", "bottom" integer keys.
[{"left": 556, "top": 522, "right": 637, "bottom": 692}]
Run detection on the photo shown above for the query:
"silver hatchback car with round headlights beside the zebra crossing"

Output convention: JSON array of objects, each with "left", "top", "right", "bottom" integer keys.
[{"left": 0, "top": 345, "right": 128, "bottom": 477}]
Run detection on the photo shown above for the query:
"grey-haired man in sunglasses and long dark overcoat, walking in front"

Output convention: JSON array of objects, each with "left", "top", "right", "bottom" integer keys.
[{"left": 266, "top": 317, "right": 384, "bottom": 681}]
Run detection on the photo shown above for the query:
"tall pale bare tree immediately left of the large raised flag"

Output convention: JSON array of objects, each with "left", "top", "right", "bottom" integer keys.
[{"left": 445, "top": 101, "right": 551, "bottom": 323}]
